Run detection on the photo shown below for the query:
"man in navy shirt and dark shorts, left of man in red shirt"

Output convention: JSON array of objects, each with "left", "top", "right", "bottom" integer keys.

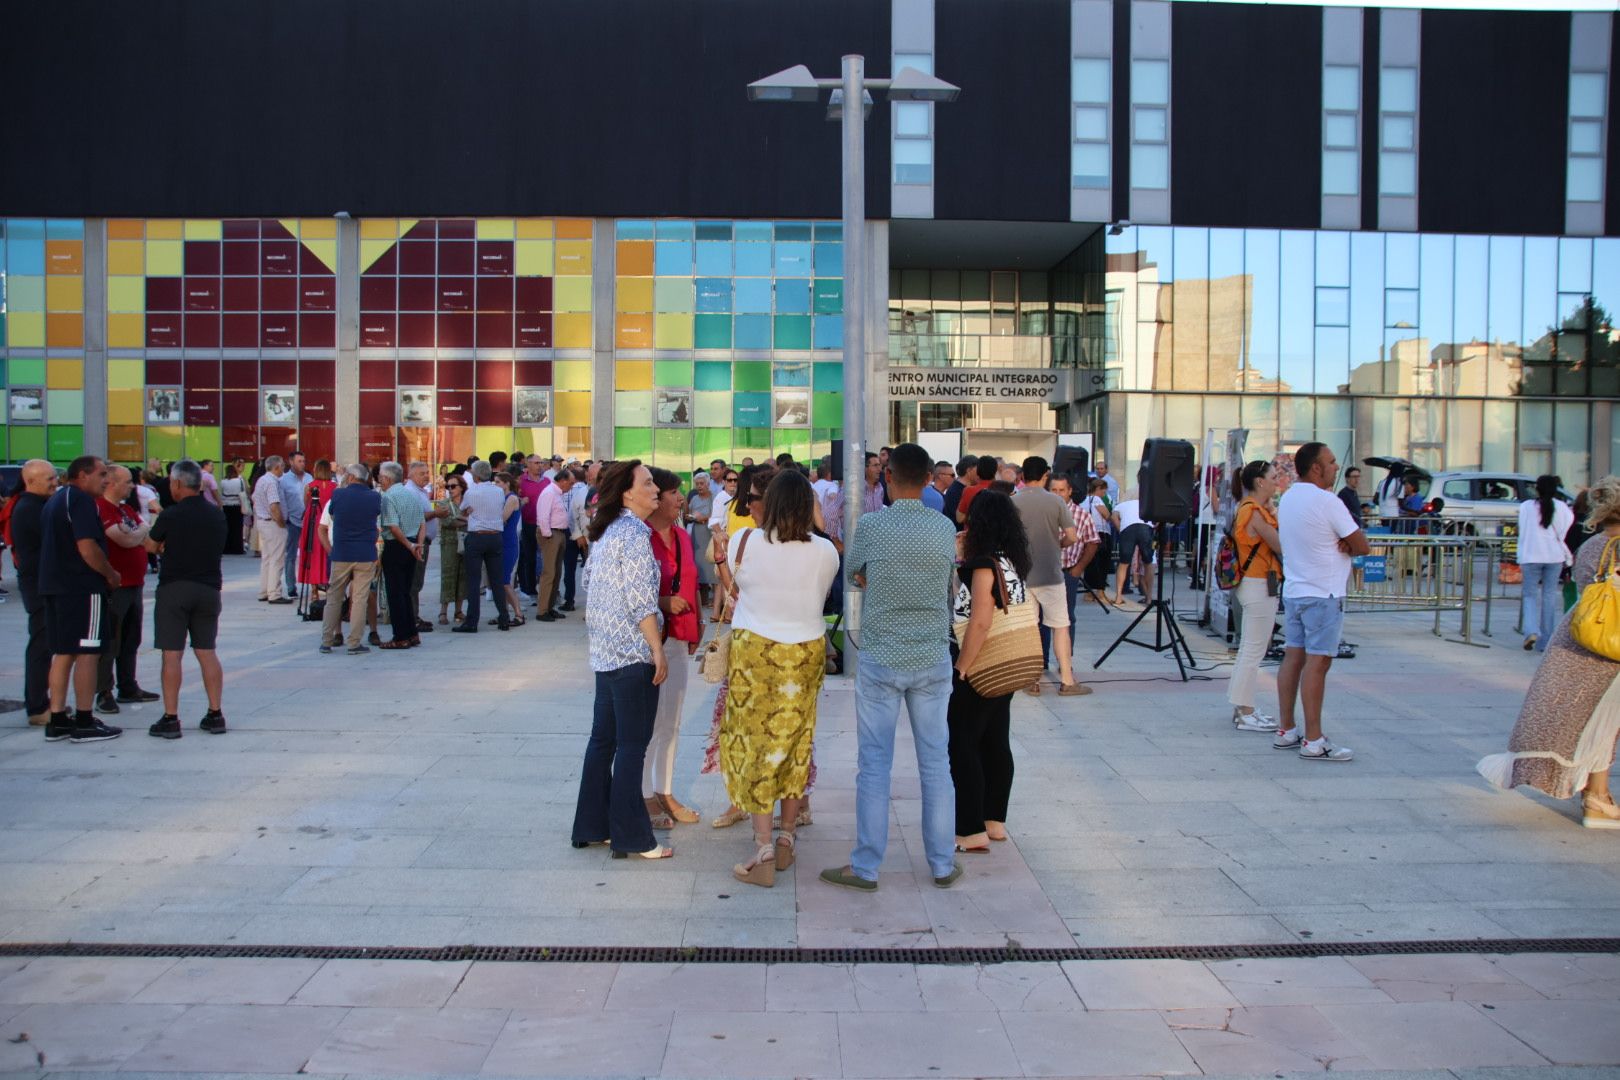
[{"left": 39, "top": 455, "right": 123, "bottom": 743}]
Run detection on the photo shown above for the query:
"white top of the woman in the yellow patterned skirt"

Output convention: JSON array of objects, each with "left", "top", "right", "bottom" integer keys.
[{"left": 726, "top": 528, "right": 838, "bottom": 644}]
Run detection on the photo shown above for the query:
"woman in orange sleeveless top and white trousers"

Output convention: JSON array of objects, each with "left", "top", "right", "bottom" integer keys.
[{"left": 1226, "top": 460, "right": 1283, "bottom": 732}]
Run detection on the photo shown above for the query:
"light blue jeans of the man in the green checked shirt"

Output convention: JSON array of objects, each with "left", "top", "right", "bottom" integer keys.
[{"left": 849, "top": 653, "right": 956, "bottom": 881}]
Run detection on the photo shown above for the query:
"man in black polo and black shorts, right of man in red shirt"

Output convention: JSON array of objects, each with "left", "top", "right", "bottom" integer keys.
[{"left": 146, "top": 458, "right": 225, "bottom": 738}]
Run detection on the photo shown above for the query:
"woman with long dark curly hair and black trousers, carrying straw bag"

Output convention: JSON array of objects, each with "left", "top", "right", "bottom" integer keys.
[{"left": 946, "top": 489, "right": 1032, "bottom": 852}]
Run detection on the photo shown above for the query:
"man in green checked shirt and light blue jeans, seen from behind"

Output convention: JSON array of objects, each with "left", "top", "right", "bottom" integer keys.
[{"left": 821, "top": 442, "right": 962, "bottom": 892}]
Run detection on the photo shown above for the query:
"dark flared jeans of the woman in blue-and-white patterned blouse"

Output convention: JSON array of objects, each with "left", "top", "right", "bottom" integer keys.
[{"left": 573, "top": 664, "right": 658, "bottom": 853}]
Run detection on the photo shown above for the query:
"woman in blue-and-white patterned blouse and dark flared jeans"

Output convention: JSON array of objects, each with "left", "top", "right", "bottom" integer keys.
[{"left": 573, "top": 461, "right": 676, "bottom": 858}]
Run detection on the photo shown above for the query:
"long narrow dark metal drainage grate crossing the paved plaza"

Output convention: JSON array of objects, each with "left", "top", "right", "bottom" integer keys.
[{"left": 0, "top": 938, "right": 1620, "bottom": 963}]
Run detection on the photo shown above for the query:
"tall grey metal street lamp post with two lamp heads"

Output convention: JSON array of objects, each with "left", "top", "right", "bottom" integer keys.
[{"left": 748, "top": 55, "right": 961, "bottom": 661}]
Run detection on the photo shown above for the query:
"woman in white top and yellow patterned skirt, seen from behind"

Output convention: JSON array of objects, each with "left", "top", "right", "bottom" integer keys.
[{"left": 719, "top": 470, "right": 838, "bottom": 887}]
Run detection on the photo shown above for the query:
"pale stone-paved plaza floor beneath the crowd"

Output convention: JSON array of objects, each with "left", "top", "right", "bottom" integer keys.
[{"left": 0, "top": 559, "right": 1620, "bottom": 1077}]
